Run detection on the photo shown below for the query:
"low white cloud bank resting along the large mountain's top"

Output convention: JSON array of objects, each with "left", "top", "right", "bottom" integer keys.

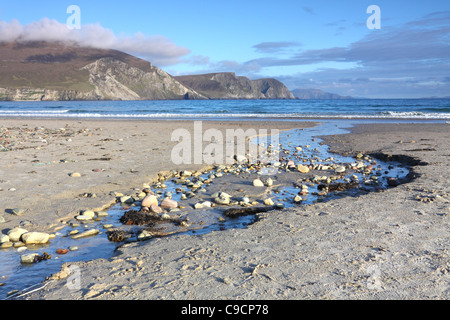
[{"left": 0, "top": 18, "right": 190, "bottom": 66}]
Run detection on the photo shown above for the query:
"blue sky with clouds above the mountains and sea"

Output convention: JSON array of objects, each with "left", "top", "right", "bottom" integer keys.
[{"left": 0, "top": 0, "right": 450, "bottom": 98}]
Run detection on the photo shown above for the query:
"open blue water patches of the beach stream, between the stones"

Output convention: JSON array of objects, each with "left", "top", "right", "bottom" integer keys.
[{"left": 0, "top": 121, "right": 409, "bottom": 299}]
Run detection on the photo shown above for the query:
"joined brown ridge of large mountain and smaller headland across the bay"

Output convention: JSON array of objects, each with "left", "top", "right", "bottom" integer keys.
[{"left": 0, "top": 41, "right": 294, "bottom": 101}]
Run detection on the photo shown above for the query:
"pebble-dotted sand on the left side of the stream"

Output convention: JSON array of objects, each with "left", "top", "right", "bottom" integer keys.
[{"left": 0, "top": 119, "right": 313, "bottom": 232}]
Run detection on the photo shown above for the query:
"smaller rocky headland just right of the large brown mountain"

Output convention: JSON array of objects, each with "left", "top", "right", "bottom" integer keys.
[{"left": 175, "top": 72, "right": 295, "bottom": 99}]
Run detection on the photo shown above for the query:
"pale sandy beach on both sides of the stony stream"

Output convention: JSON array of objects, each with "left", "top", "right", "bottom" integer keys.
[{"left": 0, "top": 119, "right": 450, "bottom": 300}]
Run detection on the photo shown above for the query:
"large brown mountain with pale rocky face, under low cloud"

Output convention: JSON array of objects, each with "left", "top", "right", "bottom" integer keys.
[{"left": 0, "top": 42, "right": 206, "bottom": 100}]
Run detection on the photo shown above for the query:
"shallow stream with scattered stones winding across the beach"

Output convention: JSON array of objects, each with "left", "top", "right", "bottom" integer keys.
[{"left": 0, "top": 120, "right": 409, "bottom": 299}]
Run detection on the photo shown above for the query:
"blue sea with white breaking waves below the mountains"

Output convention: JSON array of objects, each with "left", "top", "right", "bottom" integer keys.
[{"left": 0, "top": 99, "right": 450, "bottom": 122}]
